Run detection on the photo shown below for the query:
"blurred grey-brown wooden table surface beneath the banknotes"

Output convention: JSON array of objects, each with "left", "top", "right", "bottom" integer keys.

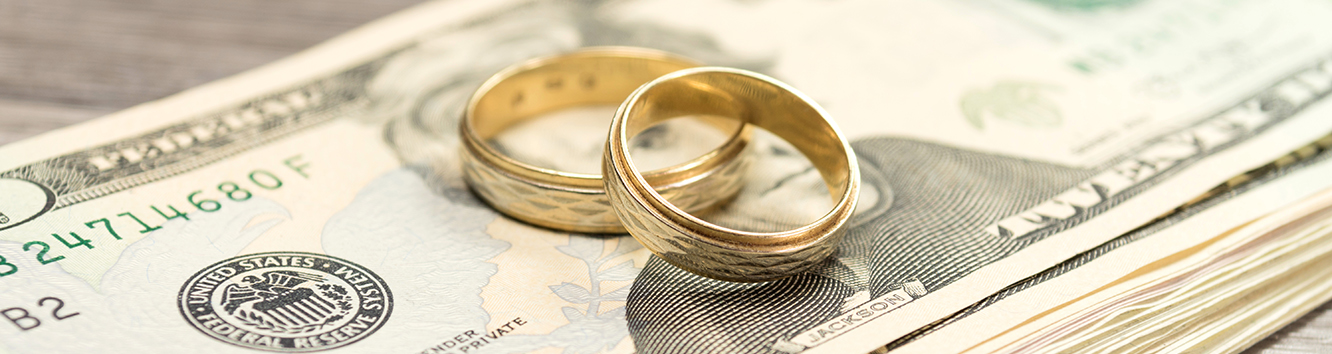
[{"left": 0, "top": 0, "right": 1332, "bottom": 353}]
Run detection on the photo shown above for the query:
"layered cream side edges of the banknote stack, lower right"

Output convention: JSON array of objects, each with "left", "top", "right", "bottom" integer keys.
[{"left": 888, "top": 136, "right": 1332, "bottom": 353}]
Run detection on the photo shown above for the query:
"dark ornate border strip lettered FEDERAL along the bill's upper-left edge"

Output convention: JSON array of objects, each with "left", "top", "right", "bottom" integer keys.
[{"left": 0, "top": 1, "right": 535, "bottom": 232}]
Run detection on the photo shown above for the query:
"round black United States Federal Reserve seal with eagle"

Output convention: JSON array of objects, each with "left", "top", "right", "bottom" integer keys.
[{"left": 177, "top": 252, "right": 393, "bottom": 353}]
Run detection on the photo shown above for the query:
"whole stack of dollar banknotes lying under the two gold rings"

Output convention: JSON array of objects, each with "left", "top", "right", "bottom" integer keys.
[{"left": 0, "top": 0, "right": 1332, "bottom": 354}]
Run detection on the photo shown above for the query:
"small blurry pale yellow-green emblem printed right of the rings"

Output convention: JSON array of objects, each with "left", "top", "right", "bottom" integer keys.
[{"left": 960, "top": 81, "right": 1063, "bottom": 130}]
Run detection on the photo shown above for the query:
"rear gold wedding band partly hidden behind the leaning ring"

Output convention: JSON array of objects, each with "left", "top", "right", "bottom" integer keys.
[{"left": 458, "top": 48, "right": 750, "bottom": 233}]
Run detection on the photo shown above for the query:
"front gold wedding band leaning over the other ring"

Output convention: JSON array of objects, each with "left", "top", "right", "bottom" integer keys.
[{"left": 602, "top": 68, "right": 860, "bottom": 282}]
